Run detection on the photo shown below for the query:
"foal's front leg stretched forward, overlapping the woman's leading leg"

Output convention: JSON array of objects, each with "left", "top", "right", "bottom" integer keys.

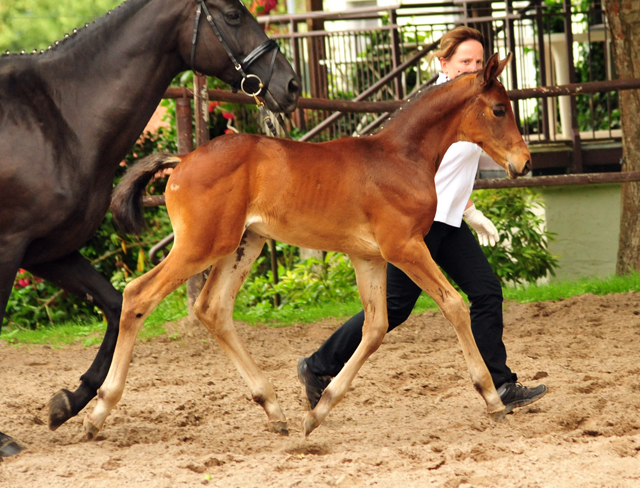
[{"left": 387, "top": 238, "right": 505, "bottom": 419}]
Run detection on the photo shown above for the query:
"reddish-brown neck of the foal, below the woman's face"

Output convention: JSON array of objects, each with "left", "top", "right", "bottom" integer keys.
[{"left": 381, "top": 77, "right": 476, "bottom": 160}]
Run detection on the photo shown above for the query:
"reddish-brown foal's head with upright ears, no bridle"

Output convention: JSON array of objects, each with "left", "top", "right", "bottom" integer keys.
[{"left": 460, "top": 54, "right": 531, "bottom": 178}]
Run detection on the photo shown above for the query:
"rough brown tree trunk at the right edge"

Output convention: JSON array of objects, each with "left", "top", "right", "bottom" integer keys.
[{"left": 604, "top": 0, "right": 640, "bottom": 275}]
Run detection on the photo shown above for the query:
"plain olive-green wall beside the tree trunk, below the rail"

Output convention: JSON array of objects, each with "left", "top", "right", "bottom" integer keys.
[{"left": 542, "top": 184, "right": 620, "bottom": 281}]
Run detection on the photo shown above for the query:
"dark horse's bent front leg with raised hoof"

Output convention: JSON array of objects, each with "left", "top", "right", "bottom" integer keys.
[{"left": 28, "top": 251, "right": 122, "bottom": 430}]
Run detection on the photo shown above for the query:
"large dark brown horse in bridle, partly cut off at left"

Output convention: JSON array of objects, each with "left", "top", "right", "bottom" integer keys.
[{"left": 0, "top": 0, "right": 300, "bottom": 455}]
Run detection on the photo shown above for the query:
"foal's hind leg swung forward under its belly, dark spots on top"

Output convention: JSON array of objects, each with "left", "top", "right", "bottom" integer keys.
[{"left": 193, "top": 231, "right": 289, "bottom": 435}]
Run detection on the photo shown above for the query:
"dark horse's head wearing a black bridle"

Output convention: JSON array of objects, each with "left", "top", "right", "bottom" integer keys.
[{"left": 180, "top": 0, "right": 300, "bottom": 112}]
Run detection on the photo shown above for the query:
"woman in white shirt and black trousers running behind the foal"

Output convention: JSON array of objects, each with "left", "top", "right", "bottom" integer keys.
[{"left": 298, "top": 27, "right": 547, "bottom": 413}]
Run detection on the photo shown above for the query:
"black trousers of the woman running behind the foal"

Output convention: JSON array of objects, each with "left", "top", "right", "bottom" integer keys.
[{"left": 307, "top": 222, "right": 517, "bottom": 388}]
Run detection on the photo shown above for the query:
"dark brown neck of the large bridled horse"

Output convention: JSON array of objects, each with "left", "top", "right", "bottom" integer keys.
[{"left": 37, "top": 0, "right": 182, "bottom": 168}]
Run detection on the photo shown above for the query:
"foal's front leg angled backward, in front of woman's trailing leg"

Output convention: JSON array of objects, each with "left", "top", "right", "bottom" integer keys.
[{"left": 303, "top": 256, "right": 389, "bottom": 436}]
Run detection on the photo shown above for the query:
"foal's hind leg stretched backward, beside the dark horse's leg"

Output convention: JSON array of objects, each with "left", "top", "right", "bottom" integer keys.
[{"left": 84, "top": 252, "right": 210, "bottom": 439}]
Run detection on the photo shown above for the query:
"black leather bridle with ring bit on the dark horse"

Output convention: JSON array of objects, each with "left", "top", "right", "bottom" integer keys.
[{"left": 191, "top": 0, "right": 280, "bottom": 98}]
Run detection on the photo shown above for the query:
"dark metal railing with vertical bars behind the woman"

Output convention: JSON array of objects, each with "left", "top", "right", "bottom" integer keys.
[{"left": 260, "top": 0, "right": 621, "bottom": 152}]
